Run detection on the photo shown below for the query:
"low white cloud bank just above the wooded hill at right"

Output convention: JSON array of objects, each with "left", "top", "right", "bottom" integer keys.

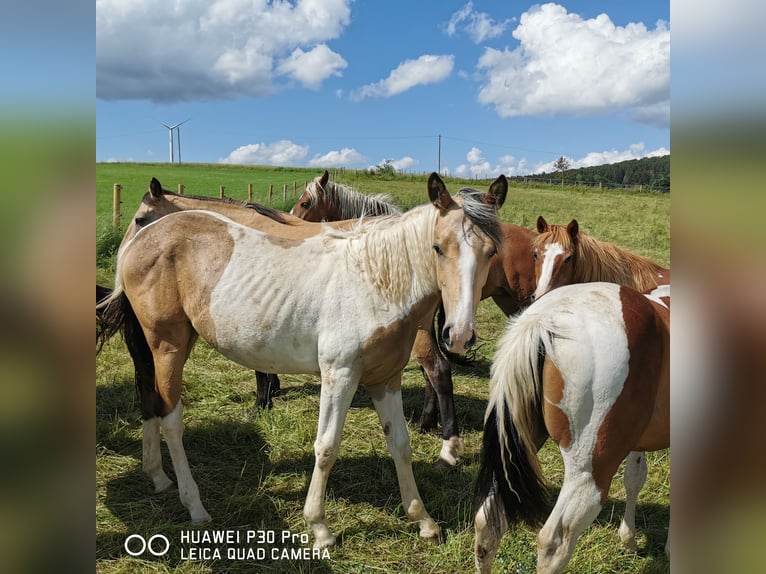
[{"left": 451, "top": 142, "right": 670, "bottom": 178}]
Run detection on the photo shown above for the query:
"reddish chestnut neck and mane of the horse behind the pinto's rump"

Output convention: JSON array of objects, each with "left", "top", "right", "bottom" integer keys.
[{"left": 576, "top": 237, "right": 670, "bottom": 292}]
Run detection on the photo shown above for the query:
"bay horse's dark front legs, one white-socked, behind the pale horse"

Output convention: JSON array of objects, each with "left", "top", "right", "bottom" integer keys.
[{"left": 412, "top": 319, "right": 462, "bottom": 466}]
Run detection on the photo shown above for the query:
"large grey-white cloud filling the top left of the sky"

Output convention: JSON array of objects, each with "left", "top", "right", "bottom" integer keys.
[{"left": 96, "top": 0, "right": 352, "bottom": 102}]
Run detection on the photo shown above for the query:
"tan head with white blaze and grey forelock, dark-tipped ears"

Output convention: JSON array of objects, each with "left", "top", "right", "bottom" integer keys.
[{"left": 428, "top": 173, "right": 508, "bottom": 353}]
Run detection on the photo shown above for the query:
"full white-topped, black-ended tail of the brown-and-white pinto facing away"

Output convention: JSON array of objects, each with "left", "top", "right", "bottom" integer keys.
[{"left": 474, "top": 315, "right": 551, "bottom": 526}]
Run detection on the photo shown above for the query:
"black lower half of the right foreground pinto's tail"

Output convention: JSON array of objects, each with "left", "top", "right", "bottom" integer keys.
[{"left": 474, "top": 405, "right": 551, "bottom": 527}]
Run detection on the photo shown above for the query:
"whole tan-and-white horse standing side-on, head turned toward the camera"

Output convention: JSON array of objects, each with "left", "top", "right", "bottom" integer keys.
[{"left": 99, "top": 173, "right": 505, "bottom": 549}]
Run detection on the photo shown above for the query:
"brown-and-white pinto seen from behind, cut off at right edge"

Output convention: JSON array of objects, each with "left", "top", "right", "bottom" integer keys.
[{"left": 474, "top": 282, "right": 670, "bottom": 574}]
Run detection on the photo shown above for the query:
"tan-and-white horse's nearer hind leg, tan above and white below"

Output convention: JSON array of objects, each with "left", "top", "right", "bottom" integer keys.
[{"left": 153, "top": 332, "right": 210, "bottom": 522}]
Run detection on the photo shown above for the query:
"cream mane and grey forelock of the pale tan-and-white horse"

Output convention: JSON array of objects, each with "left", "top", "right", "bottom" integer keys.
[{"left": 323, "top": 188, "right": 503, "bottom": 304}]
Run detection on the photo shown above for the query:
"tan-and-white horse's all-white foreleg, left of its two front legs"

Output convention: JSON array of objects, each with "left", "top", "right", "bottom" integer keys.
[{"left": 303, "top": 373, "right": 358, "bottom": 548}]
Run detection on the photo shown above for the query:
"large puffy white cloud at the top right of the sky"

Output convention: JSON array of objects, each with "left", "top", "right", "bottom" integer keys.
[{"left": 478, "top": 4, "right": 670, "bottom": 127}]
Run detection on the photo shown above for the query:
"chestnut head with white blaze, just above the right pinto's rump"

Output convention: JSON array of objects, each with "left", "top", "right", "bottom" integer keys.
[{"left": 532, "top": 215, "right": 580, "bottom": 300}]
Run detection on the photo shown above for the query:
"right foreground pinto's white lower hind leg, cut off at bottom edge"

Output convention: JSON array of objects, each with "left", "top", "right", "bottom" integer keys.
[{"left": 537, "top": 468, "right": 601, "bottom": 574}]
